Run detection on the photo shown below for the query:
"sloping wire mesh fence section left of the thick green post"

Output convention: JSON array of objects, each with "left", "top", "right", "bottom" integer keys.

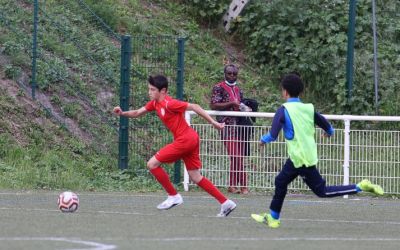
[{"left": 0, "top": 0, "right": 120, "bottom": 156}]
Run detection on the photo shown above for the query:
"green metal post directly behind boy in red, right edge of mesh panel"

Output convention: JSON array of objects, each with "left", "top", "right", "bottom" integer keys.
[{"left": 174, "top": 38, "right": 185, "bottom": 184}]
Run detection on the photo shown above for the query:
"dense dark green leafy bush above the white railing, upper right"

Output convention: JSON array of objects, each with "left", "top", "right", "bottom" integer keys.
[{"left": 236, "top": 0, "right": 400, "bottom": 114}]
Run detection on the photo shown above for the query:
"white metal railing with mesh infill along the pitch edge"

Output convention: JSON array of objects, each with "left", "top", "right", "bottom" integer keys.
[{"left": 183, "top": 111, "right": 400, "bottom": 194}]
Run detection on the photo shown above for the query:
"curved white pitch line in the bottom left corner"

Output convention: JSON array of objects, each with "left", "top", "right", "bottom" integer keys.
[{"left": 0, "top": 237, "right": 117, "bottom": 250}]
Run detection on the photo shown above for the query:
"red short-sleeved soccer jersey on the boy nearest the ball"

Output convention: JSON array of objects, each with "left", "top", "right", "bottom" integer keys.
[{"left": 145, "top": 96, "right": 193, "bottom": 139}]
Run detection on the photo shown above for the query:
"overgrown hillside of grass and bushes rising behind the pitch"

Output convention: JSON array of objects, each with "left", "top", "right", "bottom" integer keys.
[{"left": 0, "top": 0, "right": 400, "bottom": 191}]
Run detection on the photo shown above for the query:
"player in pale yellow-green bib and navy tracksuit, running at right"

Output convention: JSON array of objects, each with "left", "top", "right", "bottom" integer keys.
[{"left": 251, "top": 74, "right": 383, "bottom": 228}]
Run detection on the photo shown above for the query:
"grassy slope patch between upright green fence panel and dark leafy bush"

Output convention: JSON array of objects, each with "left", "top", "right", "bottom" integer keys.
[{"left": 88, "top": 0, "right": 279, "bottom": 108}]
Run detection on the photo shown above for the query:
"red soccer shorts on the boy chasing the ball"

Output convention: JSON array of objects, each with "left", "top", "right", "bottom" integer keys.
[{"left": 155, "top": 133, "right": 201, "bottom": 170}]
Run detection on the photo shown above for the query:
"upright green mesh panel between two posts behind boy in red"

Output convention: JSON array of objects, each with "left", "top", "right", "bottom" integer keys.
[{"left": 119, "top": 36, "right": 185, "bottom": 183}]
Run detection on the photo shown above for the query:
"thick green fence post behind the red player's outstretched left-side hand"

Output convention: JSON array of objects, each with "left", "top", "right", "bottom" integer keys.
[{"left": 118, "top": 35, "right": 132, "bottom": 170}]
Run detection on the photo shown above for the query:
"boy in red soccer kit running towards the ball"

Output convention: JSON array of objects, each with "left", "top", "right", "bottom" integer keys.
[{"left": 113, "top": 75, "right": 236, "bottom": 217}]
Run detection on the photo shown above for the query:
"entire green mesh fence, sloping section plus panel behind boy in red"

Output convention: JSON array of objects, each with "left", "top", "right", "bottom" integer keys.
[{"left": 0, "top": 0, "right": 185, "bottom": 182}]
